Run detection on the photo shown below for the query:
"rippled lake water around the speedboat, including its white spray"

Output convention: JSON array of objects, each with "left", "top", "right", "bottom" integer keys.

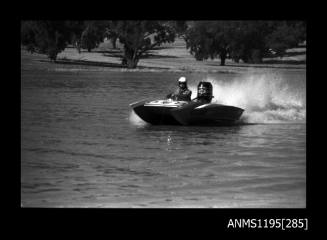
[{"left": 21, "top": 66, "right": 306, "bottom": 208}]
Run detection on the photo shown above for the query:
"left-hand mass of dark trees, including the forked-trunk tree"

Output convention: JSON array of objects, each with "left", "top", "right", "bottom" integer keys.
[{"left": 21, "top": 21, "right": 181, "bottom": 68}]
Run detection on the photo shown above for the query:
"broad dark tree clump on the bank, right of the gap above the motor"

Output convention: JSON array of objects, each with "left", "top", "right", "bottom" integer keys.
[{"left": 185, "top": 21, "right": 306, "bottom": 65}]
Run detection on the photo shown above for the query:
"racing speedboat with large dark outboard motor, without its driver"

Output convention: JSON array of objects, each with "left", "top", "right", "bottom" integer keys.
[{"left": 130, "top": 82, "right": 244, "bottom": 125}]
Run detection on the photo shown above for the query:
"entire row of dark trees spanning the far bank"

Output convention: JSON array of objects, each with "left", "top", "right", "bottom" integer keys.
[{"left": 21, "top": 21, "right": 306, "bottom": 68}]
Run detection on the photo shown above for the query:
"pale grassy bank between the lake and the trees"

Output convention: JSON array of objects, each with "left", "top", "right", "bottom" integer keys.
[{"left": 21, "top": 39, "right": 306, "bottom": 73}]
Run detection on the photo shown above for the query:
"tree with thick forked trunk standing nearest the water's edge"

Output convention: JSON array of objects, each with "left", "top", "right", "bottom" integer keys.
[{"left": 109, "top": 21, "right": 175, "bottom": 68}]
